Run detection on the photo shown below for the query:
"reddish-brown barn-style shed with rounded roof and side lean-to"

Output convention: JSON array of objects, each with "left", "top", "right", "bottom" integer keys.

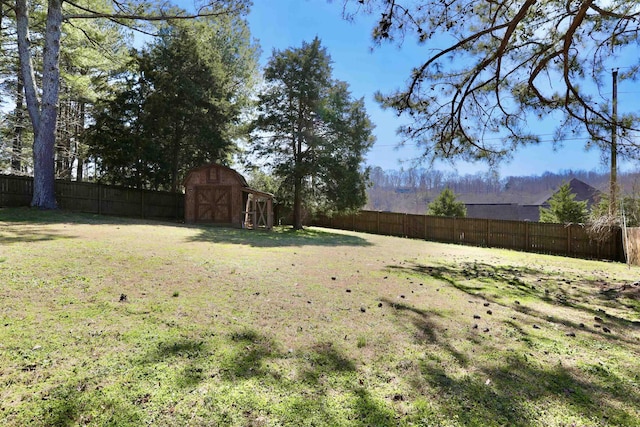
[{"left": 183, "top": 164, "right": 273, "bottom": 229}]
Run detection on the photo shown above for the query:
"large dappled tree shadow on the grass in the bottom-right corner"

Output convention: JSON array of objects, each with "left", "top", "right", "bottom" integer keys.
[{"left": 385, "top": 290, "right": 640, "bottom": 426}]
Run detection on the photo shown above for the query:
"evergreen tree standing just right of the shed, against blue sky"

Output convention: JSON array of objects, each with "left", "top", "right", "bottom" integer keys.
[{"left": 252, "top": 38, "right": 373, "bottom": 229}]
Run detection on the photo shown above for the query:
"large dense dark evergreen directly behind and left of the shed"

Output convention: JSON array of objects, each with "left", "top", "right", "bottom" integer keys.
[{"left": 88, "top": 17, "right": 257, "bottom": 191}]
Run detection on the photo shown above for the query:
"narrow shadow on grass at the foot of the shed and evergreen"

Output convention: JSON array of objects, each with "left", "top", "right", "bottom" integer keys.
[{"left": 190, "top": 226, "right": 371, "bottom": 247}]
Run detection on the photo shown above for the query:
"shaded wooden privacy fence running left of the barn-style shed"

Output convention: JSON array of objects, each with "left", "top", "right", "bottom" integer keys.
[{"left": 0, "top": 175, "right": 184, "bottom": 220}]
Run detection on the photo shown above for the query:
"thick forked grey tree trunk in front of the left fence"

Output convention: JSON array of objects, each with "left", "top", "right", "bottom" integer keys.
[{"left": 16, "top": 0, "right": 62, "bottom": 209}]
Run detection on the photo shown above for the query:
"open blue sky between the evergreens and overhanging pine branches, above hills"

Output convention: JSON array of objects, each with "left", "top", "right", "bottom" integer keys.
[{"left": 248, "top": 0, "right": 637, "bottom": 177}]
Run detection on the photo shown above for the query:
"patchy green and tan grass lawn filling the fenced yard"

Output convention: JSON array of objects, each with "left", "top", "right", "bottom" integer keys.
[{"left": 0, "top": 209, "right": 640, "bottom": 426}]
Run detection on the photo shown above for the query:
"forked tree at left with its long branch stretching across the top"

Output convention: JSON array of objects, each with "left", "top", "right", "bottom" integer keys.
[{"left": 11, "top": 0, "right": 248, "bottom": 209}]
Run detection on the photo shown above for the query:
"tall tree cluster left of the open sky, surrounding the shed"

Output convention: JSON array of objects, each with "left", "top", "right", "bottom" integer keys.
[{"left": 0, "top": 0, "right": 373, "bottom": 228}]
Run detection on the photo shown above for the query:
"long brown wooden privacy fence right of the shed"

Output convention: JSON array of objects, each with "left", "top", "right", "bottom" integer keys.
[{"left": 313, "top": 211, "right": 624, "bottom": 261}]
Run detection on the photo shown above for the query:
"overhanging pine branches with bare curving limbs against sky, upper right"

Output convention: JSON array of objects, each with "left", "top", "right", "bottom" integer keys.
[{"left": 343, "top": 0, "right": 640, "bottom": 163}]
